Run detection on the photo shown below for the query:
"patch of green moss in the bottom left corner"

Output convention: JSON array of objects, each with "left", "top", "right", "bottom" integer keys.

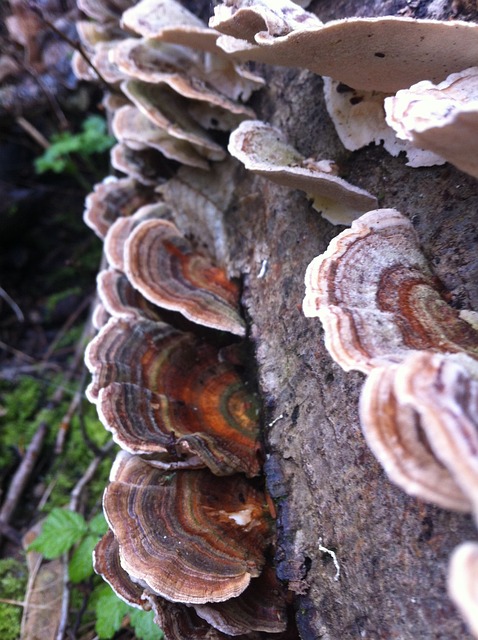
[{"left": 0, "top": 558, "right": 27, "bottom": 640}]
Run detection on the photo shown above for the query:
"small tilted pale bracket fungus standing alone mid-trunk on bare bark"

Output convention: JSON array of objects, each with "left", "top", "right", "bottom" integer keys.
[{"left": 228, "top": 120, "right": 377, "bottom": 224}]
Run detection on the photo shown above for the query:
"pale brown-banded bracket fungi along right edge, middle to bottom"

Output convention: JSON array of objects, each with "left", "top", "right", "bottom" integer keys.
[{"left": 303, "top": 209, "right": 478, "bottom": 633}]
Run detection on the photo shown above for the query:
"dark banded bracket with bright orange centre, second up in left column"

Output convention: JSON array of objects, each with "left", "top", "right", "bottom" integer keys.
[{"left": 86, "top": 315, "right": 260, "bottom": 476}]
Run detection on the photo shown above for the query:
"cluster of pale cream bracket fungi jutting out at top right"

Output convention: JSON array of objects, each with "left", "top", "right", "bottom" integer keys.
[{"left": 210, "top": 0, "right": 478, "bottom": 177}]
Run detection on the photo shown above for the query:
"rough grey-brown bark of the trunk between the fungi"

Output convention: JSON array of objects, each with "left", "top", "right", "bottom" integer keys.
[{"left": 221, "top": 0, "right": 478, "bottom": 640}]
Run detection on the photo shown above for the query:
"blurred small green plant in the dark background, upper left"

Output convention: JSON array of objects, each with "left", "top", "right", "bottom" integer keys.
[{"left": 35, "top": 115, "right": 115, "bottom": 189}]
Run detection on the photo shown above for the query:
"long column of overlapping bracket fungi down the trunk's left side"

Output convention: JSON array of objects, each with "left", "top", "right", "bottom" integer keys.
[{"left": 73, "top": 0, "right": 294, "bottom": 640}]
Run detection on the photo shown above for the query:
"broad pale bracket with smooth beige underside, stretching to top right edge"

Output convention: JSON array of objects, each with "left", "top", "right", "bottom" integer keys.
[{"left": 216, "top": 16, "right": 478, "bottom": 93}]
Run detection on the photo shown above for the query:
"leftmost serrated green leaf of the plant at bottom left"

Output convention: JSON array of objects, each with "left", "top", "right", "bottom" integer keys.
[{"left": 28, "top": 507, "right": 87, "bottom": 560}]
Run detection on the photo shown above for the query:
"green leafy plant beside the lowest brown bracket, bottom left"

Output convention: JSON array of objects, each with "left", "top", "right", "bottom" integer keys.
[{"left": 29, "top": 508, "right": 163, "bottom": 640}]
